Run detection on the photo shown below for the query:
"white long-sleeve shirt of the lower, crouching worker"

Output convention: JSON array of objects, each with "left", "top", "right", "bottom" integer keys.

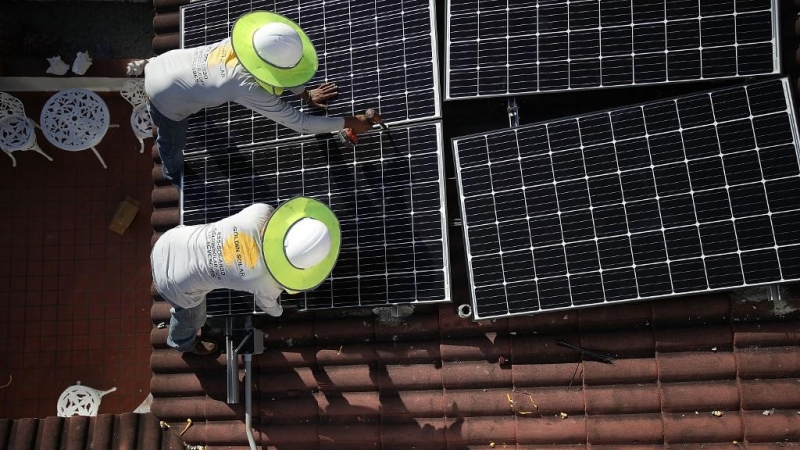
[{"left": 150, "top": 203, "right": 283, "bottom": 310}]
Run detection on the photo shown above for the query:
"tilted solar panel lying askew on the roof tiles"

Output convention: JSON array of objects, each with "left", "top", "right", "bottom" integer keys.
[{"left": 453, "top": 79, "right": 800, "bottom": 318}]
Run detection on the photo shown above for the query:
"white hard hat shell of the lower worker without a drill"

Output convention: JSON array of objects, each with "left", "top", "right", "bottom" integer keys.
[{"left": 283, "top": 217, "right": 331, "bottom": 269}]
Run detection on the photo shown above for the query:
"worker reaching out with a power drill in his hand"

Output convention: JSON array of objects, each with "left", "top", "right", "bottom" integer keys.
[{"left": 144, "top": 11, "right": 372, "bottom": 184}]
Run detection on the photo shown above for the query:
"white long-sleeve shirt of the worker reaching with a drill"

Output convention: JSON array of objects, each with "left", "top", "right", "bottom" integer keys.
[{"left": 144, "top": 39, "right": 344, "bottom": 134}]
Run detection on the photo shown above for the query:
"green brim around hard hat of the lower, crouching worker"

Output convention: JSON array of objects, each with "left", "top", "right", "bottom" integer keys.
[{"left": 262, "top": 197, "right": 342, "bottom": 294}]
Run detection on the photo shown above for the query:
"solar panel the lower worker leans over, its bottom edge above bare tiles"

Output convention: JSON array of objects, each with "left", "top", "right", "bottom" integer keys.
[{"left": 181, "top": 122, "right": 450, "bottom": 315}]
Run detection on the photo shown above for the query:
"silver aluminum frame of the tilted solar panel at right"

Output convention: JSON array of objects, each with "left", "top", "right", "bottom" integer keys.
[{"left": 451, "top": 78, "right": 800, "bottom": 321}]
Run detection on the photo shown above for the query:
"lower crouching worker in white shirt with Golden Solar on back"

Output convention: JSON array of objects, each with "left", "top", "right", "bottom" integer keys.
[{"left": 150, "top": 197, "right": 341, "bottom": 355}]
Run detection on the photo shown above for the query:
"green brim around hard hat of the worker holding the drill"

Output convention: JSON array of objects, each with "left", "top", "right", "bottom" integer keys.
[{"left": 231, "top": 11, "right": 319, "bottom": 88}]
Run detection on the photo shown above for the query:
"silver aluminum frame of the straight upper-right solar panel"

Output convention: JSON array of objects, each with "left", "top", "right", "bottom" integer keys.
[{"left": 443, "top": 0, "right": 781, "bottom": 101}]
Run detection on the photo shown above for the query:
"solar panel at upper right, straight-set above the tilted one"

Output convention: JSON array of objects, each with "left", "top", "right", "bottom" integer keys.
[{"left": 445, "top": 0, "right": 780, "bottom": 99}]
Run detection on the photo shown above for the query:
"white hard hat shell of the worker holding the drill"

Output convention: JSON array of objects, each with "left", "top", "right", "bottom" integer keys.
[{"left": 253, "top": 22, "right": 303, "bottom": 69}]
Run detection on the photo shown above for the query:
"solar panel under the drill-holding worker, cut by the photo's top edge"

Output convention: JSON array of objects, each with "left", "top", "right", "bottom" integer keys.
[{"left": 181, "top": 0, "right": 440, "bottom": 154}]
